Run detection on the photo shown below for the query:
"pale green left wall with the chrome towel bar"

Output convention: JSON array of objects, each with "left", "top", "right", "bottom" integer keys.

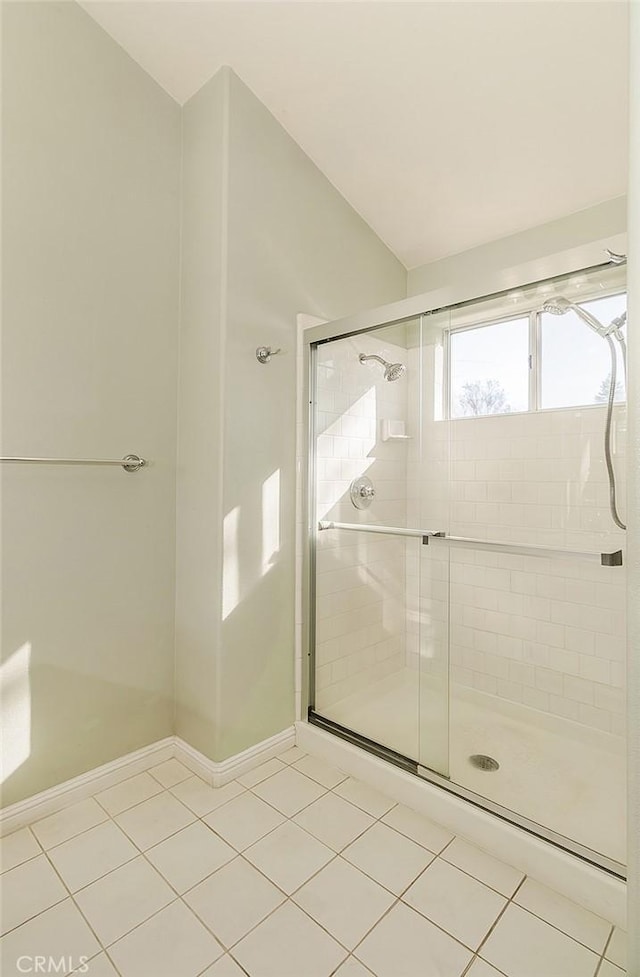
[{"left": 2, "top": 3, "right": 180, "bottom": 803}]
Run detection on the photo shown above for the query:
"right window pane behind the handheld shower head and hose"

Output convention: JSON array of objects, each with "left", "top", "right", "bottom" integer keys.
[{"left": 540, "top": 293, "right": 626, "bottom": 408}]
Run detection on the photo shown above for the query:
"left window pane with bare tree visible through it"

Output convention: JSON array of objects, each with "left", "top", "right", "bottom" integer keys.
[{"left": 449, "top": 316, "right": 529, "bottom": 417}]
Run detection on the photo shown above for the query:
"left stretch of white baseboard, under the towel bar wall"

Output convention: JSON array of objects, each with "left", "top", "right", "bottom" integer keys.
[{"left": 0, "top": 736, "right": 175, "bottom": 835}]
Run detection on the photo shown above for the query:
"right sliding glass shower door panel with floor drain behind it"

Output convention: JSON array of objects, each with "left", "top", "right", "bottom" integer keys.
[{"left": 442, "top": 273, "right": 626, "bottom": 871}]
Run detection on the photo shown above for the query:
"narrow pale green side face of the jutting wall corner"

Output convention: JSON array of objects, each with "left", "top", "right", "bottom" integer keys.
[{"left": 175, "top": 72, "right": 228, "bottom": 756}]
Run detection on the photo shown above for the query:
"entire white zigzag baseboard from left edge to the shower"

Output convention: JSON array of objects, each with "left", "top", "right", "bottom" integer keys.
[{"left": 0, "top": 726, "right": 295, "bottom": 835}]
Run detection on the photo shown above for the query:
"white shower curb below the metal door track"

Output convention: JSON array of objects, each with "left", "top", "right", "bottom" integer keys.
[{"left": 296, "top": 722, "right": 627, "bottom": 927}]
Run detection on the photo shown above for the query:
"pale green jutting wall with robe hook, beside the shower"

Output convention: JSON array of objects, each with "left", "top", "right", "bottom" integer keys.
[{"left": 177, "top": 69, "right": 406, "bottom": 759}]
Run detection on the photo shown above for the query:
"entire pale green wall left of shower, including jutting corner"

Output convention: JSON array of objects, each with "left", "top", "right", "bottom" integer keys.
[{"left": 2, "top": 13, "right": 406, "bottom": 803}]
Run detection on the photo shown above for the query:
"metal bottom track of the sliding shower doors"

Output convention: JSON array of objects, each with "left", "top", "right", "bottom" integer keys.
[{"left": 307, "top": 709, "right": 627, "bottom": 881}]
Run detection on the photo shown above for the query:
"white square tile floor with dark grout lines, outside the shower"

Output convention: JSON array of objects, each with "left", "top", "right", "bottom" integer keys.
[{"left": 0, "top": 748, "right": 626, "bottom": 977}]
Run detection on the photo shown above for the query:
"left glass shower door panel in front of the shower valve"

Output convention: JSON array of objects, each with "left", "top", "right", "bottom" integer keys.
[{"left": 313, "top": 322, "right": 421, "bottom": 760}]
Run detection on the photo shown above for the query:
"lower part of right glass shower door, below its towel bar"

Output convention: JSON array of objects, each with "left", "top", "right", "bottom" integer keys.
[{"left": 444, "top": 540, "right": 626, "bottom": 865}]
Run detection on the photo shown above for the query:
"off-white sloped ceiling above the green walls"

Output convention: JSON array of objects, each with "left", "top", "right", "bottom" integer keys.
[{"left": 82, "top": 0, "right": 628, "bottom": 268}]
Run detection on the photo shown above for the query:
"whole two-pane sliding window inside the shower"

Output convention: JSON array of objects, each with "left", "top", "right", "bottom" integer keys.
[{"left": 447, "top": 285, "right": 627, "bottom": 418}]
